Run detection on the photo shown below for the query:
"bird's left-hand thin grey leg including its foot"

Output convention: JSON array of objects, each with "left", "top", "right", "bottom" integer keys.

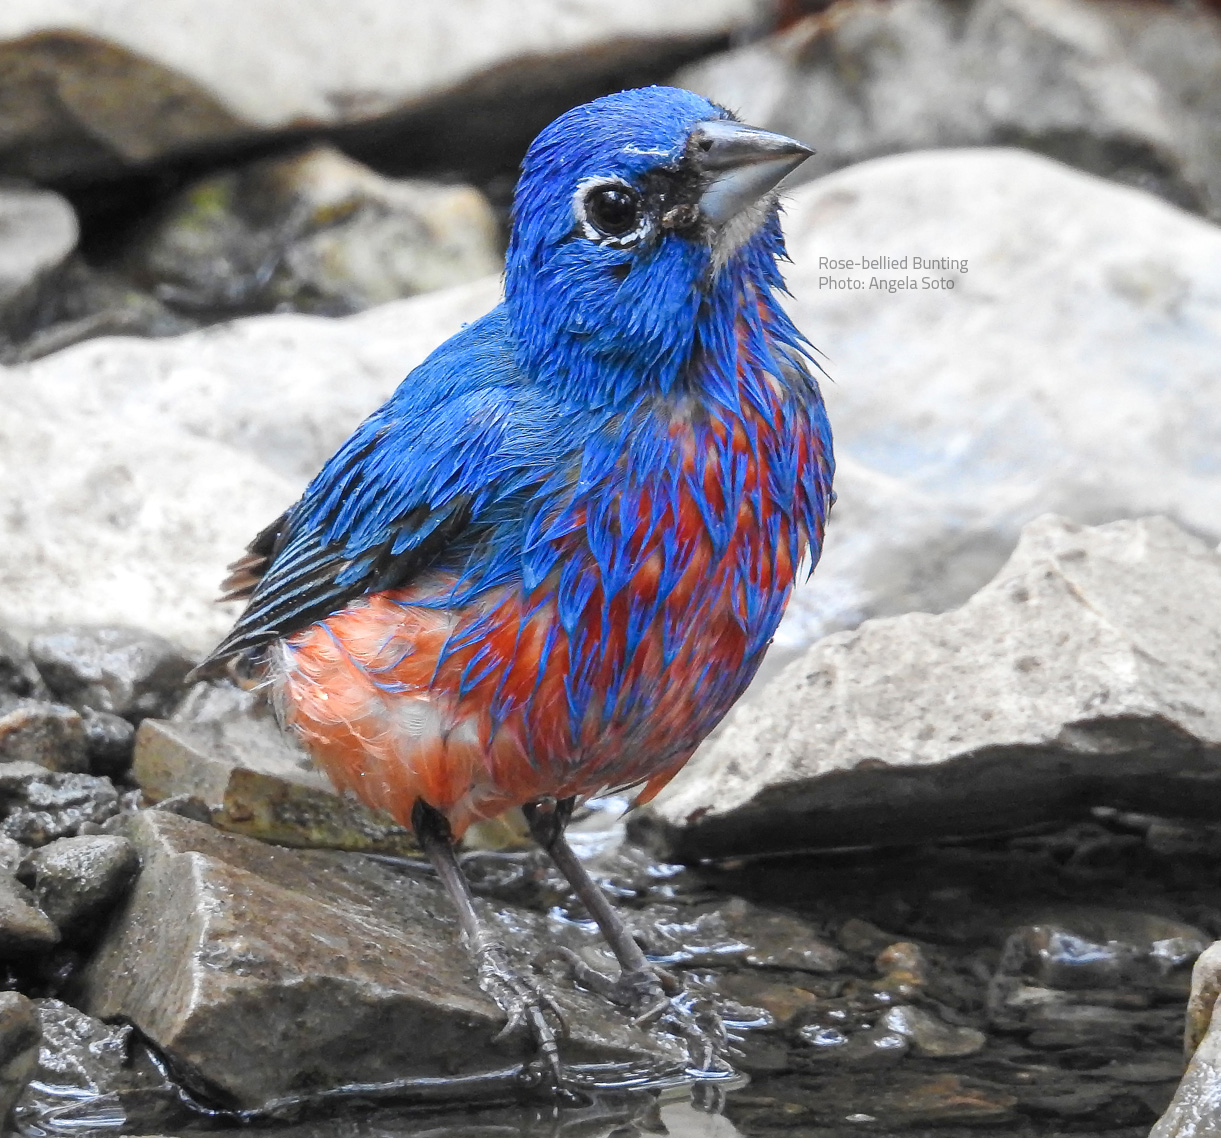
[{"left": 411, "top": 799, "right": 567, "bottom": 1089}]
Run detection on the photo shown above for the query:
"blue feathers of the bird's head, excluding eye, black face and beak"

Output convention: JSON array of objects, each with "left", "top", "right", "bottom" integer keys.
[{"left": 505, "top": 87, "right": 784, "bottom": 407}]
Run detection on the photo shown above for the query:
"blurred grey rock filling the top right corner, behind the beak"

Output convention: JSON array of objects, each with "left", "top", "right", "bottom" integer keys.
[{"left": 675, "top": 0, "right": 1221, "bottom": 216}]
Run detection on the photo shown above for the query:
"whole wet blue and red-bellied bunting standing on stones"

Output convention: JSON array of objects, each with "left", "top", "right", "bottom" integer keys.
[{"left": 200, "top": 87, "right": 834, "bottom": 1085}]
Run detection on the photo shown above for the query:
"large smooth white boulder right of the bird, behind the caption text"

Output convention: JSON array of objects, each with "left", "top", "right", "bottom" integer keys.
[{"left": 781, "top": 150, "right": 1221, "bottom": 646}]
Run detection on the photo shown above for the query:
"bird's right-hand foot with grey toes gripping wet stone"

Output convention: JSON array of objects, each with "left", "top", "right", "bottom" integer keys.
[{"left": 546, "top": 948, "right": 729, "bottom": 1073}]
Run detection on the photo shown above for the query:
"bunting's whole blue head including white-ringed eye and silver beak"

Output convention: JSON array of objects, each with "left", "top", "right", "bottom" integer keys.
[{"left": 505, "top": 87, "right": 812, "bottom": 405}]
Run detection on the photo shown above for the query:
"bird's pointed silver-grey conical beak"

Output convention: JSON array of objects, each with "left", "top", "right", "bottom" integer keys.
[{"left": 687, "top": 120, "right": 814, "bottom": 226}]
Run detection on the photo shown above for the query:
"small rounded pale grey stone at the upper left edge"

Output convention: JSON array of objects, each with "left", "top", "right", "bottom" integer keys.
[{"left": 0, "top": 184, "right": 78, "bottom": 344}]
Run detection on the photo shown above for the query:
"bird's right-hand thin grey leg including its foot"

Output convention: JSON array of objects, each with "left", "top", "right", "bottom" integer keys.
[{"left": 523, "top": 799, "right": 728, "bottom": 1070}]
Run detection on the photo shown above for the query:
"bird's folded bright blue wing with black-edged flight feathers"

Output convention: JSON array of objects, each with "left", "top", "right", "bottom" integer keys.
[{"left": 197, "top": 306, "right": 573, "bottom": 674}]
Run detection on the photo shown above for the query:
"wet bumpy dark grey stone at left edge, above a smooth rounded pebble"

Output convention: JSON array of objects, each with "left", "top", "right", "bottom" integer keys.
[{"left": 0, "top": 762, "right": 120, "bottom": 846}]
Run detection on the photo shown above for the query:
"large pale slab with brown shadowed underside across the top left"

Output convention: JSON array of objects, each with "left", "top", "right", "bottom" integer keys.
[{"left": 0, "top": 0, "right": 756, "bottom": 179}]
